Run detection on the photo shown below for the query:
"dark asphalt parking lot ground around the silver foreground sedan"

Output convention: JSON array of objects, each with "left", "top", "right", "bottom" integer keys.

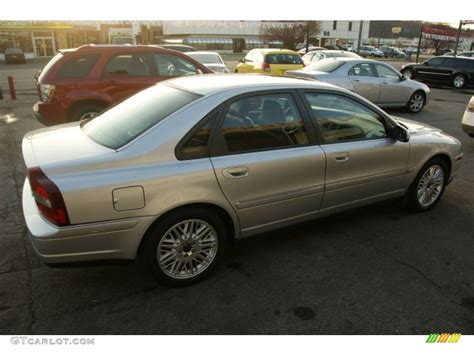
[{"left": 0, "top": 68, "right": 474, "bottom": 335}]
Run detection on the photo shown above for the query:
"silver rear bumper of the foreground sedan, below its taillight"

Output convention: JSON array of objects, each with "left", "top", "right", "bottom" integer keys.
[{"left": 23, "top": 180, "right": 155, "bottom": 264}]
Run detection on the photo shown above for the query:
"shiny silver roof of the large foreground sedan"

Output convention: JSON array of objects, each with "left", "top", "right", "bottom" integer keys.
[{"left": 165, "top": 74, "right": 343, "bottom": 96}]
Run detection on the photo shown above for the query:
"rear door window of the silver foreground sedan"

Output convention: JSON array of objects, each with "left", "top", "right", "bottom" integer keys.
[{"left": 221, "top": 93, "right": 309, "bottom": 153}]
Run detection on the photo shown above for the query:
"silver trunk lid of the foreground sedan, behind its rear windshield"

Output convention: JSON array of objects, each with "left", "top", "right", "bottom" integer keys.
[{"left": 22, "top": 122, "right": 115, "bottom": 168}]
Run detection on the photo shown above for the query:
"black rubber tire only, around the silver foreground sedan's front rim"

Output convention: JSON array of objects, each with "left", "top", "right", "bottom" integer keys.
[{"left": 406, "top": 158, "right": 449, "bottom": 212}]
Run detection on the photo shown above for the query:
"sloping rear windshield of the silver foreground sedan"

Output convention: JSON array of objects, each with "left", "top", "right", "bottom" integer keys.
[{"left": 82, "top": 84, "right": 199, "bottom": 149}]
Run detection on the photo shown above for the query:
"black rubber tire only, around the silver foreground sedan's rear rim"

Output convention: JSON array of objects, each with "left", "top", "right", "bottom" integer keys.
[{"left": 141, "top": 207, "right": 228, "bottom": 287}]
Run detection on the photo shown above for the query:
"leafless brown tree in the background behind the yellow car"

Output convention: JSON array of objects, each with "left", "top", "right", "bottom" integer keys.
[{"left": 261, "top": 21, "right": 320, "bottom": 49}]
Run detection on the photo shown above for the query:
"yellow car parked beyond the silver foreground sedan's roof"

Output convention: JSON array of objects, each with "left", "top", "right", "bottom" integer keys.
[{"left": 235, "top": 48, "right": 304, "bottom": 75}]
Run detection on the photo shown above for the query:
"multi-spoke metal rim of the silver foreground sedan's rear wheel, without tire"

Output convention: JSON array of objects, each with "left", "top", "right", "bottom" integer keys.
[{"left": 157, "top": 219, "right": 218, "bottom": 279}]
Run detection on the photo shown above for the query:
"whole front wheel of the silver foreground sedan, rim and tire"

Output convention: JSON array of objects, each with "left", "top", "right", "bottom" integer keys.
[{"left": 408, "top": 158, "right": 448, "bottom": 212}]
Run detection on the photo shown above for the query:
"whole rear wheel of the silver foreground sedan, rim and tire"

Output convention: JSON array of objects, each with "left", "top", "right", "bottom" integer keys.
[{"left": 142, "top": 208, "right": 227, "bottom": 286}]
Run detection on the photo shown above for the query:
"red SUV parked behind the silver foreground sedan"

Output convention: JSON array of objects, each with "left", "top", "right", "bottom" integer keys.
[{"left": 33, "top": 45, "right": 212, "bottom": 125}]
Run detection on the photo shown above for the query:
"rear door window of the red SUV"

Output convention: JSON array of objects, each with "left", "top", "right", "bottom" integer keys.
[{"left": 104, "top": 53, "right": 151, "bottom": 76}]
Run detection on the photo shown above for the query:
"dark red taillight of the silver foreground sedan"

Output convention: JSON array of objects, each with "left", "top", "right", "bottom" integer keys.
[{"left": 28, "top": 167, "right": 70, "bottom": 226}]
